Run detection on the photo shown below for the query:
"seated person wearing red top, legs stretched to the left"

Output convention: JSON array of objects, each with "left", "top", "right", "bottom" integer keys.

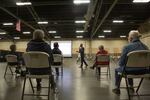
[{"left": 90, "top": 45, "right": 108, "bottom": 75}]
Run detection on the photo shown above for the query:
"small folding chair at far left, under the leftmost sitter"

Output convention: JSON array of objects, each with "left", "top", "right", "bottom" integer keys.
[{"left": 4, "top": 54, "right": 19, "bottom": 77}]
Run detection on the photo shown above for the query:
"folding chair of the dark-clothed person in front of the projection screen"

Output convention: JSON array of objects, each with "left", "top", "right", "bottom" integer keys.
[{"left": 52, "top": 54, "right": 63, "bottom": 76}]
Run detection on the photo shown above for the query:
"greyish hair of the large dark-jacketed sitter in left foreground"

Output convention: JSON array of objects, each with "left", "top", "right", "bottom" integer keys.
[{"left": 33, "top": 29, "right": 44, "bottom": 40}]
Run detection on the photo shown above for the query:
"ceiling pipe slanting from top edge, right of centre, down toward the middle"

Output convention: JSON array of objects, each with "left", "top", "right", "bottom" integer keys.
[{"left": 91, "top": 0, "right": 118, "bottom": 38}]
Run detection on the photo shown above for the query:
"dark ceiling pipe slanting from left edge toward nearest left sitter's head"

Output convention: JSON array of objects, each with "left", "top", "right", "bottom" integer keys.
[{"left": 0, "top": 6, "right": 35, "bottom": 30}]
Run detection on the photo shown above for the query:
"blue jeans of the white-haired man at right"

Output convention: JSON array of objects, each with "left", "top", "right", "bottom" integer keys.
[{"left": 115, "top": 67, "right": 150, "bottom": 88}]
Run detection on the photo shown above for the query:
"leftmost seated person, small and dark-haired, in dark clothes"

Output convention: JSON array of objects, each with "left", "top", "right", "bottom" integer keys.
[{"left": 9, "top": 44, "right": 21, "bottom": 74}]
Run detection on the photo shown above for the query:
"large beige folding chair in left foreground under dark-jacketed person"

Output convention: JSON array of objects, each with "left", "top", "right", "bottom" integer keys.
[{"left": 22, "top": 52, "right": 53, "bottom": 100}]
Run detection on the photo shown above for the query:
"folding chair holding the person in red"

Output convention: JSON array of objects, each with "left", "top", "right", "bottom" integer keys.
[{"left": 96, "top": 54, "right": 111, "bottom": 76}]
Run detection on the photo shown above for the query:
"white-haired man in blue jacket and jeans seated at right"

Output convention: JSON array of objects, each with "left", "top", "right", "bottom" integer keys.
[{"left": 113, "top": 30, "right": 148, "bottom": 94}]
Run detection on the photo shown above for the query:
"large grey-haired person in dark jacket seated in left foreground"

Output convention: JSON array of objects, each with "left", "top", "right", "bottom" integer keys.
[{"left": 26, "top": 29, "right": 55, "bottom": 91}]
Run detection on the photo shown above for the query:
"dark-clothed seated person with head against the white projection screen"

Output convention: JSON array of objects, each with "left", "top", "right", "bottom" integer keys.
[{"left": 52, "top": 42, "right": 62, "bottom": 76}]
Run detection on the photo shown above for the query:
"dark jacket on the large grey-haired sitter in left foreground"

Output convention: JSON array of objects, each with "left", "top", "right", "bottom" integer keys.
[{"left": 26, "top": 40, "right": 53, "bottom": 63}]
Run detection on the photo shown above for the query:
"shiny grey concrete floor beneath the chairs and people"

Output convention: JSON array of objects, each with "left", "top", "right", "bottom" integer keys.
[{"left": 0, "top": 58, "right": 150, "bottom": 100}]
